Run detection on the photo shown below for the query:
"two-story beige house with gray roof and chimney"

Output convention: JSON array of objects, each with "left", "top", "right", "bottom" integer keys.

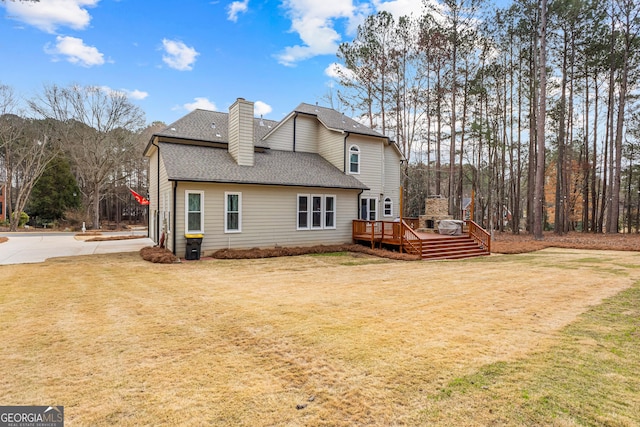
[{"left": 144, "top": 98, "right": 402, "bottom": 256}]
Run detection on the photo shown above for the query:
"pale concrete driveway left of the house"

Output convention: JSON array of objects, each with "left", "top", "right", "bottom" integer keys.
[{"left": 0, "top": 231, "right": 154, "bottom": 265}]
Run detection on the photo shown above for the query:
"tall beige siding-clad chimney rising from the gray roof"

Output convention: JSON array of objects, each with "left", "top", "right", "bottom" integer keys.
[{"left": 229, "top": 98, "right": 254, "bottom": 166}]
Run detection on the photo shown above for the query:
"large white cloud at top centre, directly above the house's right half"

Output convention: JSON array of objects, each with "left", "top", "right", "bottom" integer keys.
[{"left": 277, "top": 0, "right": 365, "bottom": 66}]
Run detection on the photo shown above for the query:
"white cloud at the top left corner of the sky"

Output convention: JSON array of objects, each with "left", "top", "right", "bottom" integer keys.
[{"left": 3, "top": 0, "right": 99, "bottom": 33}]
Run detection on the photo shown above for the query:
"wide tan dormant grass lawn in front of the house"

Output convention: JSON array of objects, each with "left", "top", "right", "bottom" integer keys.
[{"left": 0, "top": 248, "right": 640, "bottom": 426}]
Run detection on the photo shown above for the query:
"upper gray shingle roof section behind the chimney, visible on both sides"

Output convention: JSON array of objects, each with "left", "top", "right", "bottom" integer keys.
[{"left": 156, "top": 110, "right": 278, "bottom": 147}]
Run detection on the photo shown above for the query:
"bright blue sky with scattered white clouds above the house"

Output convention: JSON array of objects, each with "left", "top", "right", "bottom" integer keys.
[{"left": 0, "top": 0, "right": 500, "bottom": 124}]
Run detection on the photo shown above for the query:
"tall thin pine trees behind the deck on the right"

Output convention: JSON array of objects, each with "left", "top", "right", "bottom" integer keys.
[{"left": 337, "top": 0, "right": 640, "bottom": 237}]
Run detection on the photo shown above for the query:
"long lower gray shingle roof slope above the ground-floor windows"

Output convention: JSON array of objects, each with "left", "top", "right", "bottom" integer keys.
[{"left": 159, "top": 143, "right": 368, "bottom": 190}]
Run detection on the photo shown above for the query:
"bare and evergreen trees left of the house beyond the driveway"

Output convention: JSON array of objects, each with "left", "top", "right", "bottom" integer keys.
[{"left": 0, "top": 85, "right": 159, "bottom": 230}]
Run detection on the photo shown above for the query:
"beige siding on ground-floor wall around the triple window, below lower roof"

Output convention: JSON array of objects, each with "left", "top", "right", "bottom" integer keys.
[{"left": 176, "top": 183, "right": 358, "bottom": 257}]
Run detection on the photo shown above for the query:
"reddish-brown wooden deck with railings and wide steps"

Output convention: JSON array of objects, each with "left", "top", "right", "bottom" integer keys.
[{"left": 352, "top": 220, "right": 491, "bottom": 259}]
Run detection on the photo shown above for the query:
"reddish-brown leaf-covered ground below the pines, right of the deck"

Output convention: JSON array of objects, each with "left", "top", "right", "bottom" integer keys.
[{"left": 491, "top": 232, "right": 640, "bottom": 254}]
